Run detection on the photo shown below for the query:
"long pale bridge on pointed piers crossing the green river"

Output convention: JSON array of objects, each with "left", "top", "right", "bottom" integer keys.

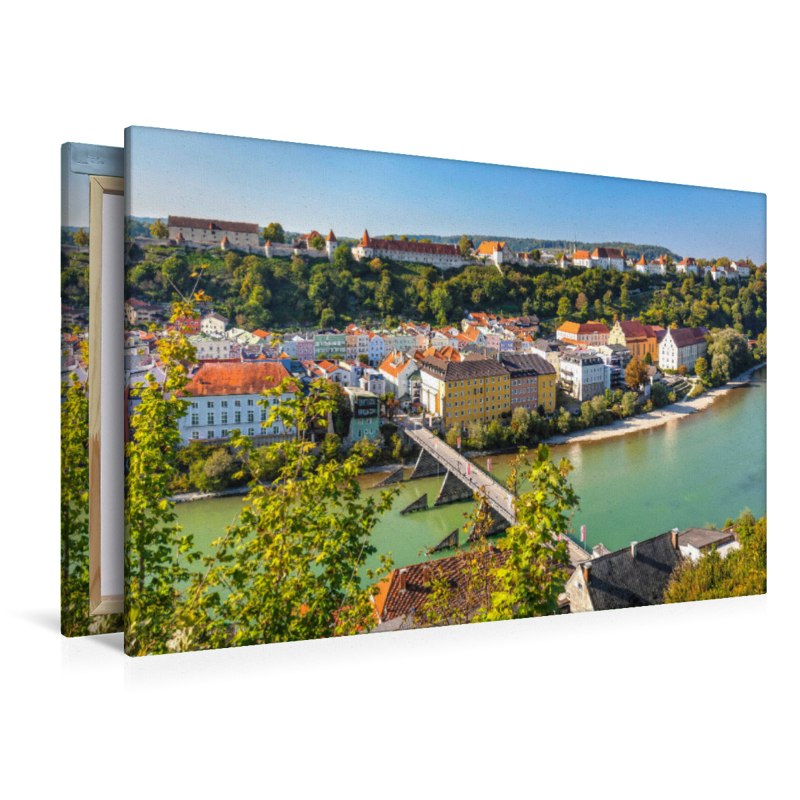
[{"left": 398, "top": 417, "right": 592, "bottom": 566}]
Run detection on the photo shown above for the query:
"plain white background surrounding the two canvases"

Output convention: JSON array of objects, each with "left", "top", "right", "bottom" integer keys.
[{"left": 0, "top": 0, "right": 798, "bottom": 798}]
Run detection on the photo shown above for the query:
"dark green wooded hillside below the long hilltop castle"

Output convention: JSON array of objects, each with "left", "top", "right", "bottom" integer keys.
[{"left": 109, "top": 239, "right": 767, "bottom": 336}]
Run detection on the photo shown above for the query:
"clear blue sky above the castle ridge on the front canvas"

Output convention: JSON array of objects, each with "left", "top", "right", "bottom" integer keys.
[{"left": 122, "top": 127, "right": 766, "bottom": 264}]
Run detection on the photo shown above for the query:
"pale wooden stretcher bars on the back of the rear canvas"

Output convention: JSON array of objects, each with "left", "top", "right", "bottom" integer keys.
[{"left": 88, "top": 175, "right": 124, "bottom": 615}]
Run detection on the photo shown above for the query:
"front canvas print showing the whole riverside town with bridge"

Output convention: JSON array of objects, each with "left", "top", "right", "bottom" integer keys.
[{"left": 125, "top": 127, "right": 767, "bottom": 655}]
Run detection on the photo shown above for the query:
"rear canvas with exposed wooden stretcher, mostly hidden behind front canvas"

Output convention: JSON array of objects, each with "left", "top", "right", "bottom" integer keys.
[{"left": 60, "top": 142, "right": 125, "bottom": 636}]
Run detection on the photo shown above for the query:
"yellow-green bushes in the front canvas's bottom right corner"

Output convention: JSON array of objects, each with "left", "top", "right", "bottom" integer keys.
[{"left": 664, "top": 510, "right": 767, "bottom": 603}]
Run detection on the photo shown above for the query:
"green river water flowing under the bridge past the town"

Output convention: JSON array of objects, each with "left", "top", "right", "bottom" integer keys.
[{"left": 176, "top": 367, "right": 767, "bottom": 580}]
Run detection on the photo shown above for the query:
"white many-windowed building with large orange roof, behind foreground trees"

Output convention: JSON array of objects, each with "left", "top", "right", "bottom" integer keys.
[{"left": 178, "top": 361, "right": 298, "bottom": 445}]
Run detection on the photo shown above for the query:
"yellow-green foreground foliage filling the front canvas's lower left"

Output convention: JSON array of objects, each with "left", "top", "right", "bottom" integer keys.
[{"left": 125, "top": 295, "right": 397, "bottom": 655}]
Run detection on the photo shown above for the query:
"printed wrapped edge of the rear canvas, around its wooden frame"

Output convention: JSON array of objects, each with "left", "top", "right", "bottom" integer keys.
[{"left": 59, "top": 142, "right": 123, "bottom": 636}]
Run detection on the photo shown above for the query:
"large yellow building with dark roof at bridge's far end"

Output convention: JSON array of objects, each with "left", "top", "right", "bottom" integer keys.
[{"left": 419, "top": 357, "right": 511, "bottom": 428}]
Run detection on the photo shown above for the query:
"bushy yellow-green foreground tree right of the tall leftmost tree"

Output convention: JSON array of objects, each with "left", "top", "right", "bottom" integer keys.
[{"left": 208, "top": 379, "right": 396, "bottom": 646}]
